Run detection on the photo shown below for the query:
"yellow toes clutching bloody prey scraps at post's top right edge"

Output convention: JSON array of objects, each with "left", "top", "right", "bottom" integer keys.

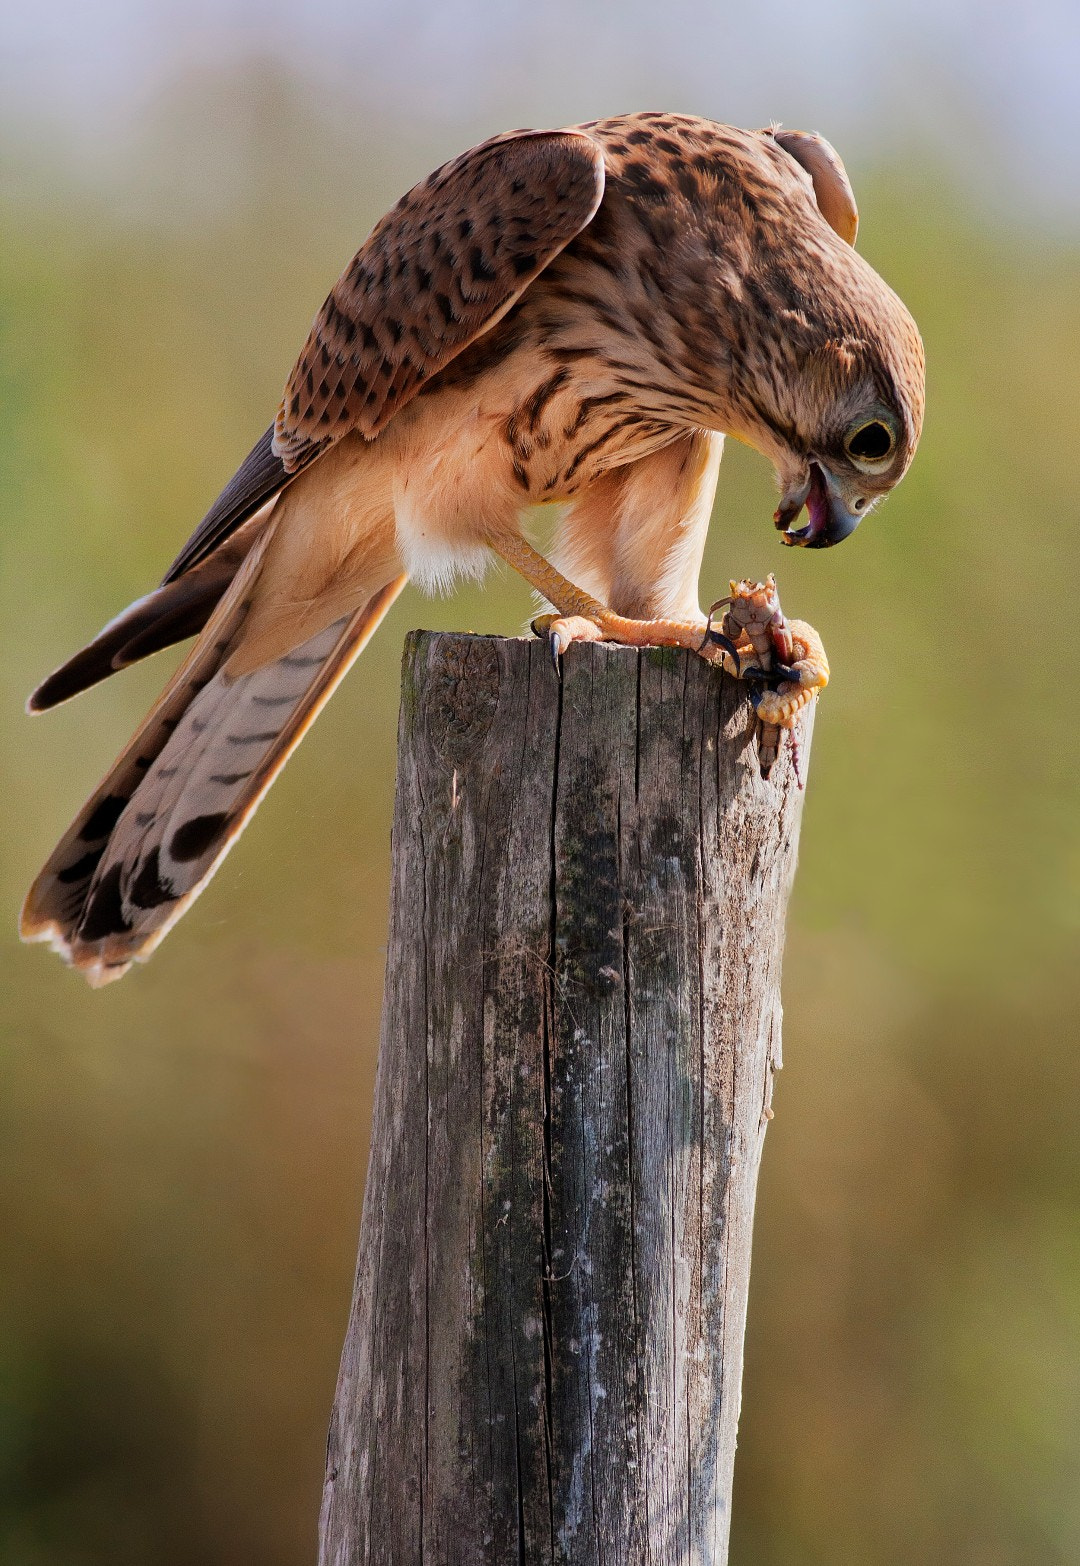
[{"left": 709, "top": 575, "right": 828, "bottom": 786}]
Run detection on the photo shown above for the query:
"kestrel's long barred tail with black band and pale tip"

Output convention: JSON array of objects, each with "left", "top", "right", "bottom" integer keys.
[{"left": 22, "top": 529, "right": 405, "bottom": 987}]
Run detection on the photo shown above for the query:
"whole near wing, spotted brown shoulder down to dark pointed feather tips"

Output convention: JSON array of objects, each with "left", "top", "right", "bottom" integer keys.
[{"left": 30, "top": 130, "right": 604, "bottom": 698}]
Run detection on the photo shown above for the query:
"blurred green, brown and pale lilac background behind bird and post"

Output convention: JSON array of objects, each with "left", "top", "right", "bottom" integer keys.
[{"left": 0, "top": 0, "right": 1080, "bottom": 1566}]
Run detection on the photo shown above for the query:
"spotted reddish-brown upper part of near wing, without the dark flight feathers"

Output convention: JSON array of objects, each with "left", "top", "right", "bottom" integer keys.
[{"left": 274, "top": 130, "right": 604, "bottom": 473}]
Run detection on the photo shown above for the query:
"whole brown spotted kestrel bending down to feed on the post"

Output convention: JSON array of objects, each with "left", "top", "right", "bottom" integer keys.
[{"left": 22, "top": 113, "right": 923, "bottom": 985}]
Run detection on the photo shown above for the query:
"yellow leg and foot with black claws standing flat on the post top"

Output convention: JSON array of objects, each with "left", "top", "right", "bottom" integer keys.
[{"left": 490, "top": 534, "right": 739, "bottom": 675}]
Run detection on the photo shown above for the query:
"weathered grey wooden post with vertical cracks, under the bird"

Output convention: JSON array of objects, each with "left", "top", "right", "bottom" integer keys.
[{"left": 319, "top": 633, "right": 809, "bottom": 1566}]
